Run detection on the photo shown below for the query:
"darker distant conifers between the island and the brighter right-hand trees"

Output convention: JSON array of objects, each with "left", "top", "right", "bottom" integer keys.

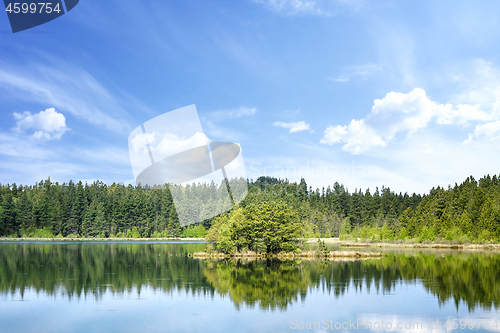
[{"left": 242, "top": 177, "right": 422, "bottom": 237}]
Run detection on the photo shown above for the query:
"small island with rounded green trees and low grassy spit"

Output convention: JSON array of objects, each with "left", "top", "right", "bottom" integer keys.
[{"left": 197, "top": 201, "right": 382, "bottom": 259}]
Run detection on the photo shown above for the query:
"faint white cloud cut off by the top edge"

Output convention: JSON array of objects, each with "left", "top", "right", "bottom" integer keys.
[{"left": 253, "top": 0, "right": 364, "bottom": 16}]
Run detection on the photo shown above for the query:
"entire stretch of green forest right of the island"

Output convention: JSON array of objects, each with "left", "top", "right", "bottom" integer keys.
[{"left": 232, "top": 175, "right": 500, "bottom": 243}]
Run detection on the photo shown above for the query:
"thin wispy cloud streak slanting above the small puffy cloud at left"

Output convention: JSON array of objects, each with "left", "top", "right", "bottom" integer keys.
[{"left": 0, "top": 61, "right": 133, "bottom": 132}]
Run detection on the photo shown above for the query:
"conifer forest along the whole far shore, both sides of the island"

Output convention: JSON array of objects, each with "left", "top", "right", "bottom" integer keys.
[{"left": 0, "top": 175, "right": 500, "bottom": 242}]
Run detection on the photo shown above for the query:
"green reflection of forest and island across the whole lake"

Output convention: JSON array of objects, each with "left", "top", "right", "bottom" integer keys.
[{"left": 0, "top": 243, "right": 500, "bottom": 310}]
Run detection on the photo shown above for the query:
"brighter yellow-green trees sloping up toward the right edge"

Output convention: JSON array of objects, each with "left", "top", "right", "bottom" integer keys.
[{"left": 341, "top": 175, "right": 500, "bottom": 243}]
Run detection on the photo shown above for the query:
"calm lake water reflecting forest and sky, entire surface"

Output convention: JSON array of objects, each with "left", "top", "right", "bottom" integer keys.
[{"left": 0, "top": 242, "right": 500, "bottom": 332}]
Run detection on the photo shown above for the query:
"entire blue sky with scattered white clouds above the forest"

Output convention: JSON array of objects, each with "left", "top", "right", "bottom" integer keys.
[{"left": 0, "top": 0, "right": 500, "bottom": 193}]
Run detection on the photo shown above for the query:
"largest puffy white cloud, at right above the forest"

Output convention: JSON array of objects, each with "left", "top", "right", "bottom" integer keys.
[{"left": 320, "top": 88, "right": 497, "bottom": 154}]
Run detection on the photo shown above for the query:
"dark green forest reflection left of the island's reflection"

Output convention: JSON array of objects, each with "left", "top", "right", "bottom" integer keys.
[{"left": 0, "top": 243, "right": 213, "bottom": 298}]
